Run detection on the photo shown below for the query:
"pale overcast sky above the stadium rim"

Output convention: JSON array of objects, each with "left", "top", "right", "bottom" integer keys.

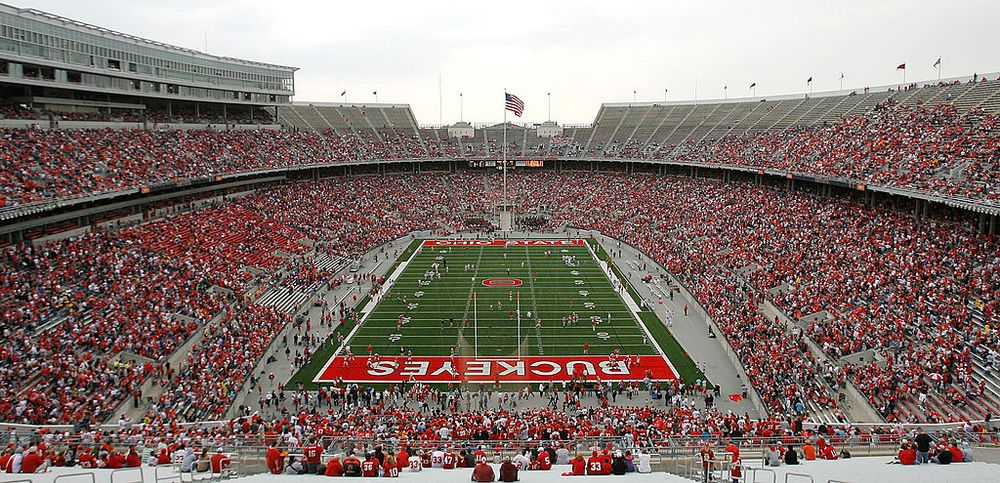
[{"left": 13, "top": 0, "right": 1000, "bottom": 124}]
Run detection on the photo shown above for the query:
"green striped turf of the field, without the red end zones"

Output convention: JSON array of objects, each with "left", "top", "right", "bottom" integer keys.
[{"left": 288, "top": 242, "right": 704, "bottom": 389}]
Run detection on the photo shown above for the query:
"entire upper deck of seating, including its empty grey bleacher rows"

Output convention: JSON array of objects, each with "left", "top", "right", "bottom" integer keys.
[{"left": 0, "top": 78, "right": 1000, "bottom": 212}]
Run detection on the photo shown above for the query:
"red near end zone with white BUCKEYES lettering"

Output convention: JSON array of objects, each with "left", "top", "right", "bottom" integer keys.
[{"left": 314, "top": 355, "right": 677, "bottom": 384}]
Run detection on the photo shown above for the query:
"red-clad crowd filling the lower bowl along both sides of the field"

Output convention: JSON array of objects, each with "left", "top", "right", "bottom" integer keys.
[{"left": 0, "top": 171, "right": 1000, "bottom": 432}]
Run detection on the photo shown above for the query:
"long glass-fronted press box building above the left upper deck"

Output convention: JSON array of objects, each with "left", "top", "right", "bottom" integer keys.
[{"left": 0, "top": 4, "right": 297, "bottom": 122}]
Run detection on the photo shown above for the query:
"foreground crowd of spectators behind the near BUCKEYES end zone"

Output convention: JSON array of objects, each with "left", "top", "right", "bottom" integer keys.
[{"left": 0, "top": 394, "right": 996, "bottom": 476}]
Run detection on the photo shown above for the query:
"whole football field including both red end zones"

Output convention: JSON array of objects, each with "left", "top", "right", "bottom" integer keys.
[{"left": 292, "top": 240, "right": 696, "bottom": 383}]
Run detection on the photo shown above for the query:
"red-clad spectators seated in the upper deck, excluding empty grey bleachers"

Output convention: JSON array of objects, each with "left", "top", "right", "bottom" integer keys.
[{"left": 0, "top": 92, "right": 1000, "bottom": 207}]
